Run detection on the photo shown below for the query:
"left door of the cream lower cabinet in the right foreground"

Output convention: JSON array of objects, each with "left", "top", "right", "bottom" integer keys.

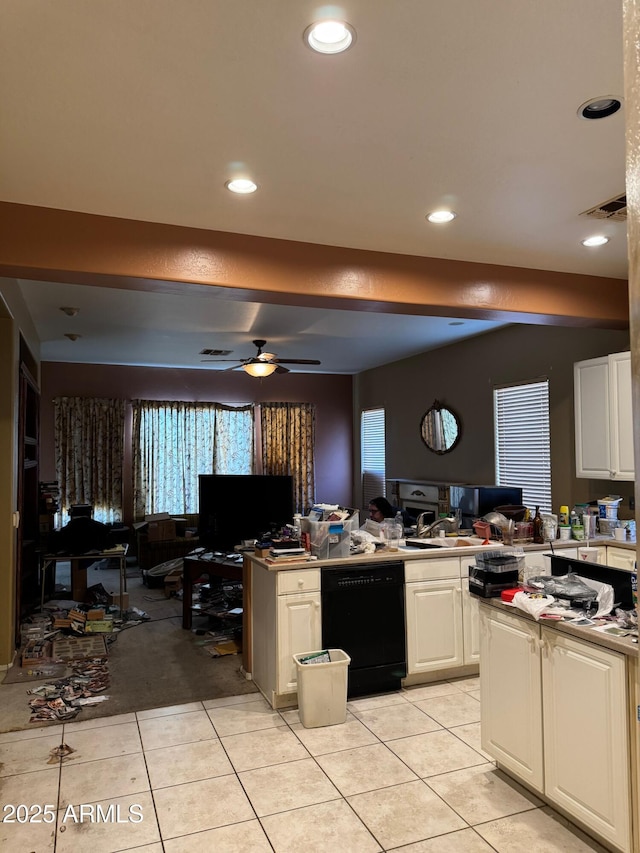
[{"left": 480, "top": 605, "right": 544, "bottom": 791}]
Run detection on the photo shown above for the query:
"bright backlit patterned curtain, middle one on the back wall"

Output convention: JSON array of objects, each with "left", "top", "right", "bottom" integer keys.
[{"left": 132, "top": 400, "right": 254, "bottom": 520}]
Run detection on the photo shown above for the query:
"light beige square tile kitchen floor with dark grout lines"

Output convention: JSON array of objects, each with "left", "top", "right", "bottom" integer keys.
[{"left": 0, "top": 678, "right": 603, "bottom": 853}]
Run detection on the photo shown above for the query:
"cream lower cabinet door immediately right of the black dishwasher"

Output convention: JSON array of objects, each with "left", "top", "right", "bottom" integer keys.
[{"left": 405, "top": 570, "right": 463, "bottom": 674}]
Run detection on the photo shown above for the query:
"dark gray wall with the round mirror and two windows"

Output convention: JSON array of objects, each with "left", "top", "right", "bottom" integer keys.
[{"left": 354, "top": 325, "right": 633, "bottom": 515}]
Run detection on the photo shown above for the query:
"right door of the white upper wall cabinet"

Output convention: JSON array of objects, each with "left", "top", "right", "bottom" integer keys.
[{"left": 609, "top": 352, "right": 635, "bottom": 480}]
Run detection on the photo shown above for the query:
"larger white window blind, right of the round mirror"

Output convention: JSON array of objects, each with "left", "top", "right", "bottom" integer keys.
[{"left": 493, "top": 379, "right": 551, "bottom": 512}]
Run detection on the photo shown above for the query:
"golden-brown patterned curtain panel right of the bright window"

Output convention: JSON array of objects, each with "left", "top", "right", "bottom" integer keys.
[{"left": 260, "top": 403, "right": 316, "bottom": 513}]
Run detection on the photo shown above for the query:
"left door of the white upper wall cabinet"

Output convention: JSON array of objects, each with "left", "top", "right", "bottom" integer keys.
[{"left": 573, "top": 356, "right": 611, "bottom": 480}]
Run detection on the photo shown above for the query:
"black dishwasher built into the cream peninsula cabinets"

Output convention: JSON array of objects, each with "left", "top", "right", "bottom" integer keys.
[{"left": 321, "top": 561, "right": 407, "bottom": 697}]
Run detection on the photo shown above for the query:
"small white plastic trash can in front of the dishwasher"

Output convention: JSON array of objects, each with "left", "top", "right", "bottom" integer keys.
[{"left": 293, "top": 649, "right": 351, "bottom": 729}]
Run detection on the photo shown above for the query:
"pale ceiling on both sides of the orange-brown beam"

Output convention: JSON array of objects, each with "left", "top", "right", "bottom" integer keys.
[{"left": 0, "top": 0, "right": 627, "bottom": 373}]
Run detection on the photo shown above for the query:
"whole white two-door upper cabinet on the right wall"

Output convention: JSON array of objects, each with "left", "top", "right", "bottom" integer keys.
[{"left": 573, "top": 352, "right": 635, "bottom": 480}]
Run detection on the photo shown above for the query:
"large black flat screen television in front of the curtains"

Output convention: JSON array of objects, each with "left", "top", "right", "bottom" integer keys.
[{"left": 198, "top": 474, "right": 293, "bottom": 552}]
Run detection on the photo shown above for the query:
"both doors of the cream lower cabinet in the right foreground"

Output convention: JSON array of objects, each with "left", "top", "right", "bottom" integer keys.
[{"left": 480, "top": 608, "right": 631, "bottom": 853}]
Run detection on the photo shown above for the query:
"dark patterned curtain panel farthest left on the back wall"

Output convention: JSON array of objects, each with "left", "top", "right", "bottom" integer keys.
[{"left": 53, "top": 397, "right": 125, "bottom": 524}]
